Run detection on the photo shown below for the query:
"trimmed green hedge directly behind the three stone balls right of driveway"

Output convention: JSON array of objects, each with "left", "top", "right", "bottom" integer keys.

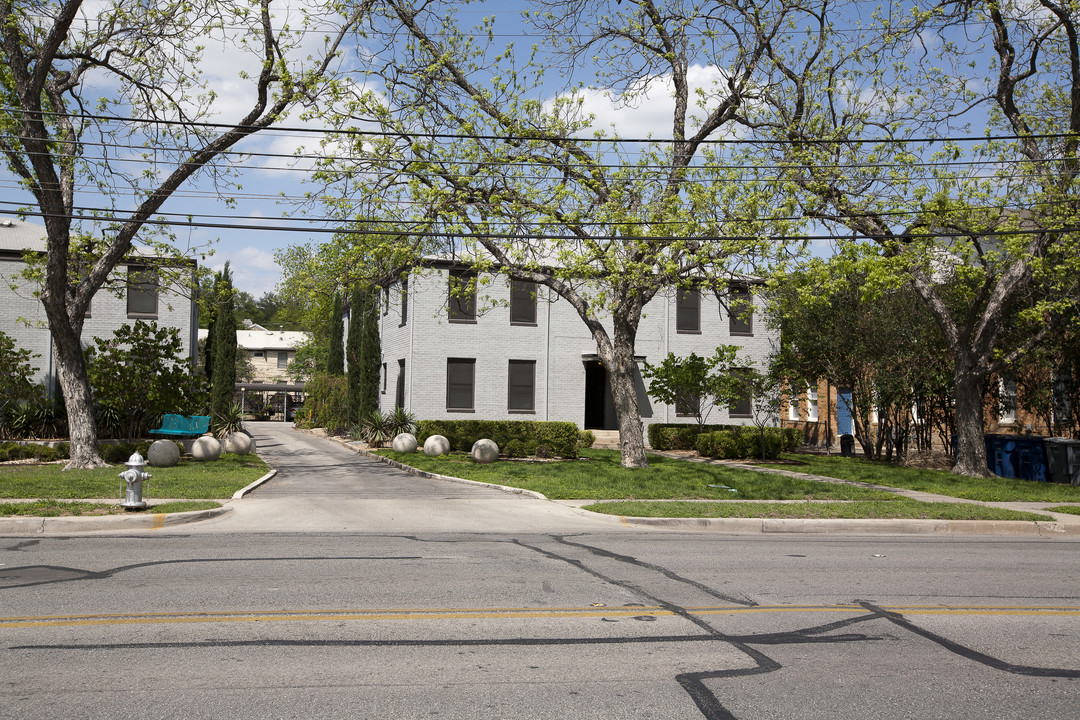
[{"left": 416, "top": 420, "right": 582, "bottom": 458}]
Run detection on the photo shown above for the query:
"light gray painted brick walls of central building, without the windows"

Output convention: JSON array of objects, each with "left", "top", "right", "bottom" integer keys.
[{"left": 380, "top": 264, "right": 779, "bottom": 440}]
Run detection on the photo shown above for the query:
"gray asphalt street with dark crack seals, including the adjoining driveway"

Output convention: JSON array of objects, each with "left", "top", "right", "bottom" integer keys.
[{"left": 0, "top": 425, "right": 1080, "bottom": 720}]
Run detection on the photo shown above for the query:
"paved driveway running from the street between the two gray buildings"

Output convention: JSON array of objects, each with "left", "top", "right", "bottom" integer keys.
[{"left": 185, "top": 422, "right": 623, "bottom": 532}]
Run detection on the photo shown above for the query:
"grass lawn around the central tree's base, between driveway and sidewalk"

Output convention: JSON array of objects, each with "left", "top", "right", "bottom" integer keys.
[{"left": 379, "top": 450, "right": 896, "bottom": 502}]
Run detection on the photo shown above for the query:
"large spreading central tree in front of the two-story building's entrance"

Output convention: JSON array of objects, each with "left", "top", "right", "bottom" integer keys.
[{"left": 322, "top": 0, "right": 802, "bottom": 467}]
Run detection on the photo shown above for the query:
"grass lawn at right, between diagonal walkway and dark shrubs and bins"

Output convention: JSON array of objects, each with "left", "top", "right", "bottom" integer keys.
[{"left": 762, "top": 453, "right": 1080, "bottom": 502}]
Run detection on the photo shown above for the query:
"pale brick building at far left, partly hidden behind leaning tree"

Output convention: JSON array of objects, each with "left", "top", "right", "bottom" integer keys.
[{"left": 0, "top": 218, "right": 199, "bottom": 389}]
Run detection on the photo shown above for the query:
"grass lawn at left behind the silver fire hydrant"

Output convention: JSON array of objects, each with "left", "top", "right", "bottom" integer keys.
[{"left": 0, "top": 453, "right": 268, "bottom": 512}]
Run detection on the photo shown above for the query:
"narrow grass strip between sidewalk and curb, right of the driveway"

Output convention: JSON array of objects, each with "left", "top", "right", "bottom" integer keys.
[{"left": 585, "top": 498, "right": 1053, "bottom": 520}]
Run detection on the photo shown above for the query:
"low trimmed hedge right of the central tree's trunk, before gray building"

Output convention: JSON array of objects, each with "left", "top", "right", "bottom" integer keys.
[{"left": 649, "top": 423, "right": 802, "bottom": 458}]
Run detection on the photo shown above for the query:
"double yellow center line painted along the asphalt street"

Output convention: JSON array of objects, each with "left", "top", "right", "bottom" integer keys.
[{"left": 0, "top": 604, "right": 1080, "bottom": 629}]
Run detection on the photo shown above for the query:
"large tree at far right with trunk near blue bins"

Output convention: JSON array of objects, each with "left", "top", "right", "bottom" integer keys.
[{"left": 743, "top": 0, "right": 1080, "bottom": 475}]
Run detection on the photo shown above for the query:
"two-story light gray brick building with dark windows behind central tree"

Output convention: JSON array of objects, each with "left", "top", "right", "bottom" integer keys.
[{"left": 380, "top": 261, "right": 779, "bottom": 430}]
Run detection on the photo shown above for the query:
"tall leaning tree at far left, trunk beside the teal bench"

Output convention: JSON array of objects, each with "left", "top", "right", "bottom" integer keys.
[{"left": 0, "top": 0, "right": 363, "bottom": 468}]
